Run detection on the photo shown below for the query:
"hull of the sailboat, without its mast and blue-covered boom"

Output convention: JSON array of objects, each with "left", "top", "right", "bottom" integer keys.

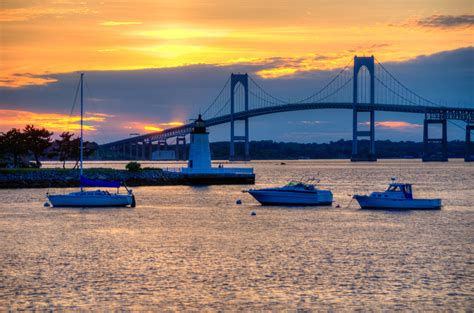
[{"left": 48, "top": 192, "right": 135, "bottom": 207}]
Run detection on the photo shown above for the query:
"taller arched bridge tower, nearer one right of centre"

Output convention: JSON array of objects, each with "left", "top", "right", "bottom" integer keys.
[{"left": 351, "top": 56, "right": 377, "bottom": 162}]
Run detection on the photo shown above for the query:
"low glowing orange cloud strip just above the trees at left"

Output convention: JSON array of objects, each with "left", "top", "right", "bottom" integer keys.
[{"left": 0, "top": 110, "right": 106, "bottom": 133}]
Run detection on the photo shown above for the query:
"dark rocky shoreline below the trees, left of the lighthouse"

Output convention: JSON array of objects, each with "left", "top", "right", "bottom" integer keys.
[{"left": 0, "top": 168, "right": 181, "bottom": 189}]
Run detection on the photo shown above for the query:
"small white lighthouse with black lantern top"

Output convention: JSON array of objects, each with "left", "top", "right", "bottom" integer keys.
[{"left": 188, "top": 114, "right": 212, "bottom": 173}]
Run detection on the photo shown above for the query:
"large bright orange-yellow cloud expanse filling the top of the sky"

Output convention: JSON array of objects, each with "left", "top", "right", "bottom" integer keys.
[{"left": 0, "top": 0, "right": 472, "bottom": 87}]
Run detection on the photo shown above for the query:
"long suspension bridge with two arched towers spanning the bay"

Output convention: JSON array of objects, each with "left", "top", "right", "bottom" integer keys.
[{"left": 101, "top": 56, "right": 474, "bottom": 161}]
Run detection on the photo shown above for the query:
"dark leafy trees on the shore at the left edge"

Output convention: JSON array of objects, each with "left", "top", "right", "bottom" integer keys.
[{"left": 0, "top": 125, "right": 98, "bottom": 168}]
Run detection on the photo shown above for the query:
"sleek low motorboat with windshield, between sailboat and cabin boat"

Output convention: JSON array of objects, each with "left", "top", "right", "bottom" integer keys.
[{"left": 246, "top": 181, "right": 332, "bottom": 206}]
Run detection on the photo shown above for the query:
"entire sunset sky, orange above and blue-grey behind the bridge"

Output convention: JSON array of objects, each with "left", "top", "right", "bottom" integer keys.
[{"left": 0, "top": 0, "right": 474, "bottom": 143}]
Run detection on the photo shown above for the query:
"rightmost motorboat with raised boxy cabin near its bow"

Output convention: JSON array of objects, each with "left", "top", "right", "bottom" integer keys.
[{"left": 353, "top": 178, "right": 441, "bottom": 210}]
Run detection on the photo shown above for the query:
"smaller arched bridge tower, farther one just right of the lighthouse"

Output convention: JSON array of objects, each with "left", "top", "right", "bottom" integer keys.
[{"left": 229, "top": 73, "right": 250, "bottom": 161}]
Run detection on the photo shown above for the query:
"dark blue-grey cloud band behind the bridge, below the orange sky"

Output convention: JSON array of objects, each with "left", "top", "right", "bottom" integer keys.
[{"left": 0, "top": 47, "right": 474, "bottom": 143}]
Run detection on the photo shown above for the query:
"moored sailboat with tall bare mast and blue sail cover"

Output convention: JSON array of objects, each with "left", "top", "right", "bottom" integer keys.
[{"left": 46, "top": 73, "right": 136, "bottom": 208}]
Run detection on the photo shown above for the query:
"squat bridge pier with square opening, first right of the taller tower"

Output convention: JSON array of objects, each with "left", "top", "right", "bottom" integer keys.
[{"left": 422, "top": 114, "right": 448, "bottom": 162}]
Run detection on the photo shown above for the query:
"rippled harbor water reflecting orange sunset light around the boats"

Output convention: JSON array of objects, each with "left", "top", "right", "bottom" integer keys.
[{"left": 0, "top": 160, "right": 474, "bottom": 311}]
